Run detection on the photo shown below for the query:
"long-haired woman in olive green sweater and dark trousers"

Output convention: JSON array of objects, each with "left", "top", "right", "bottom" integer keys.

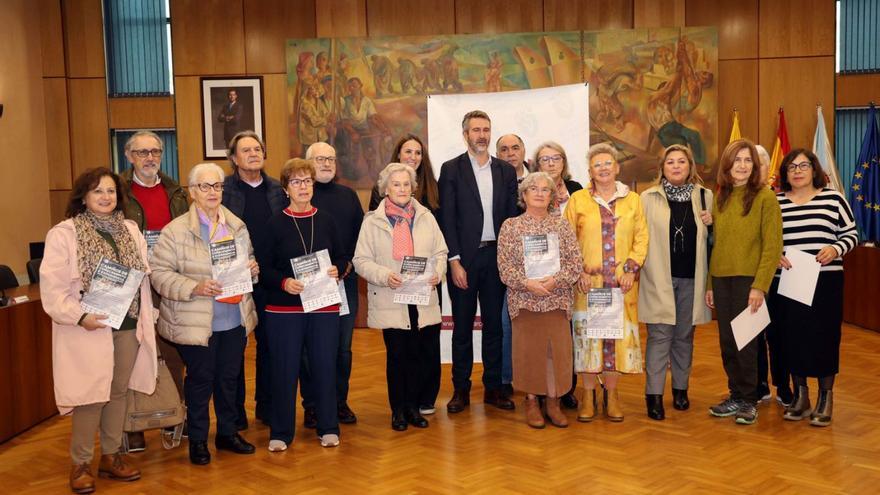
[{"left": 706, "top": 139, "right": 782, "bottom": 424}]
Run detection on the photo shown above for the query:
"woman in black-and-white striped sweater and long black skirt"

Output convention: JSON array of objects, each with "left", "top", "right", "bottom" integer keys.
[{"left": 770, "top": 149, "right": 859, "bottom": 426}]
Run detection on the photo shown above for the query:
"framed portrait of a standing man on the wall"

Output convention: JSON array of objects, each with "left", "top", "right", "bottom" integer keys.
[{"left": 200, "top": 76, "right": 265, "bottom": 160}]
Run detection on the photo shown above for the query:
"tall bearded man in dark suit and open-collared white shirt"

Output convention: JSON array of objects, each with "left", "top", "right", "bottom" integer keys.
[{"left": 438, "top": 110, "right": 519, "bottom": 413}]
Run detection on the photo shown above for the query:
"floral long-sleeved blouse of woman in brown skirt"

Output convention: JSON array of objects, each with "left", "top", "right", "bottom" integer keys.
[{"left": 498, "top": 213, "right": 583, "bottom": 318}]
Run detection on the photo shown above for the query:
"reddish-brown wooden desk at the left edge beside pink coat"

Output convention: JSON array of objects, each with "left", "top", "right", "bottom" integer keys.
[{"left": 0, "top": 284, "right": 58, "bottom": 443}]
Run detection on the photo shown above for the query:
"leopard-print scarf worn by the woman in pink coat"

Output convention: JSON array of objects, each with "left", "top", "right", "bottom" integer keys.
[{"left": 73, "top": 210, "right": 144, "bottom": 318}]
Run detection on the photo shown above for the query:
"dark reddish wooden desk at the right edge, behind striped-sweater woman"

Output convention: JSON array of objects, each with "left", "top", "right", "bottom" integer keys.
[{"left": 843, "top": 246, "right": 880, "bottom": 332}]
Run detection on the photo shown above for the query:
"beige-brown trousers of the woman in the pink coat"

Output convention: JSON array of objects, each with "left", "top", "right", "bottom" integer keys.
[{"left": 70, "top": 330, "right": 140, "bottom": 464}]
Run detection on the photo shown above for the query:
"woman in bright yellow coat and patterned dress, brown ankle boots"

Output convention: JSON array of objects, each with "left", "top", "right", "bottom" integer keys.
[{"left": 565, "top": 143, "right": 648, "bottom": 422}]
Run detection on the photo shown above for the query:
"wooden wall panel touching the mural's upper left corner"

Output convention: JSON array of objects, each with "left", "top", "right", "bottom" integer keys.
[{"left": 244, "top": 0, "right": 323, "bottom": 74}]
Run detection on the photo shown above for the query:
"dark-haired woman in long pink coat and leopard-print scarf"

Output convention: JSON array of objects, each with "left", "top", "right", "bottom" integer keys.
[{"left": 40, "top": 168, "right": 157, "bottom": 493}]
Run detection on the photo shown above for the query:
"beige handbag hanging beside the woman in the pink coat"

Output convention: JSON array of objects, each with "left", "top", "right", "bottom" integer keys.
[{"left": 122, "top": 357, "right": 186, "bottom": 451}]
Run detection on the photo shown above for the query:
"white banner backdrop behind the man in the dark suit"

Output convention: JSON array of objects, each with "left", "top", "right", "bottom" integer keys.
[{"left": 428, "top": 84, "right": 590, "bottom": 363}]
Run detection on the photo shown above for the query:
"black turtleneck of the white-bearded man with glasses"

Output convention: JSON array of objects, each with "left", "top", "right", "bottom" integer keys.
[{"left": 312, "top": 181, "right": 364, "bottom": 266}]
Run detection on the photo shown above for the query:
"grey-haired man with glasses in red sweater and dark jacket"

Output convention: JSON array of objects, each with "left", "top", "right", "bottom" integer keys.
[{"left": 119, "top": 131, "right": 189, "bottom": 452}]
